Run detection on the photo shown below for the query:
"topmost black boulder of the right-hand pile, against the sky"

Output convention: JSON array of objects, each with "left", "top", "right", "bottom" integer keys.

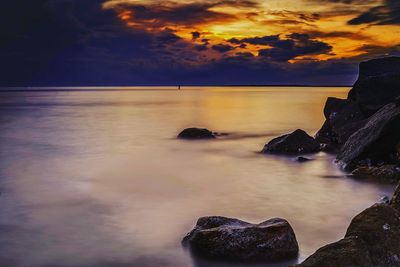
[{"left": 348, "top": 57, "right": 400, "bottom": 115}]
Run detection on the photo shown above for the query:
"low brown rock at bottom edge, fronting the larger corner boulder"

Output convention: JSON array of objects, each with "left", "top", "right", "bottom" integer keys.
[{"left": 297, "top": 237, "right": 374, "bottom": 267}]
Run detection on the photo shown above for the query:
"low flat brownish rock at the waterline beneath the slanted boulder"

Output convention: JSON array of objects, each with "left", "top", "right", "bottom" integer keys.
[{"left": 351, "top": 165, "right": 400, "bottom": 182}]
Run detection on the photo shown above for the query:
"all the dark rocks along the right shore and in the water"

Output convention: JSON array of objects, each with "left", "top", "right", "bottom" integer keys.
[{"left": 178, "top": 57, "right": 400, "bottom": 267}]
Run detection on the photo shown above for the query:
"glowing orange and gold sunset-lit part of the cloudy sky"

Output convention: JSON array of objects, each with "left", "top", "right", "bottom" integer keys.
[{"left": 103, "top": 0, "right": 400, "bottom": 63}]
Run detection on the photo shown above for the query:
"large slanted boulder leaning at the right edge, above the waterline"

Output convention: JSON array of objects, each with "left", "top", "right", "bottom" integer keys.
[{"left": 337, "top": 103, "right": 400, "bottom": 170}]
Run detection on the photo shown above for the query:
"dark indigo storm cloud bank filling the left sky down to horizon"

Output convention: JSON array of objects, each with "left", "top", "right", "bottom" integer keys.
[{"left": 0, "top": 0, "right": 394, "bottom": 86}]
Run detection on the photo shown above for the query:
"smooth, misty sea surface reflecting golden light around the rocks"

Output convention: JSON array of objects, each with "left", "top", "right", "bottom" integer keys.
[{"left": 0, "top": 87, "right": 393, "bottom": 267}]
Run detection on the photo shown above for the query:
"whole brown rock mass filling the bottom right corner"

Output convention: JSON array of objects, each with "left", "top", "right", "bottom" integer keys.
[{"left": 298, "top": 204, "right": 400, "bottom": 267}]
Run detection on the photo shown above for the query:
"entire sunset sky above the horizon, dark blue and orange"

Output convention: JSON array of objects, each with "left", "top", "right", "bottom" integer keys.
[{"left": 0, "top": 0, "right": 400, "bottom": 86}]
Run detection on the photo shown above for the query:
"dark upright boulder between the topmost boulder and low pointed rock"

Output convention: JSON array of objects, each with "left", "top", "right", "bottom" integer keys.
[{"left": 315, "top": 97, "right": 365, "bottom": 145}]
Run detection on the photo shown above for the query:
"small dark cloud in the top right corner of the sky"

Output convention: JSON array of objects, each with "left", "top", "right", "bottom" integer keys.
[{"left": 348, "top": 0, "right": 400, "bottom": 25}]
